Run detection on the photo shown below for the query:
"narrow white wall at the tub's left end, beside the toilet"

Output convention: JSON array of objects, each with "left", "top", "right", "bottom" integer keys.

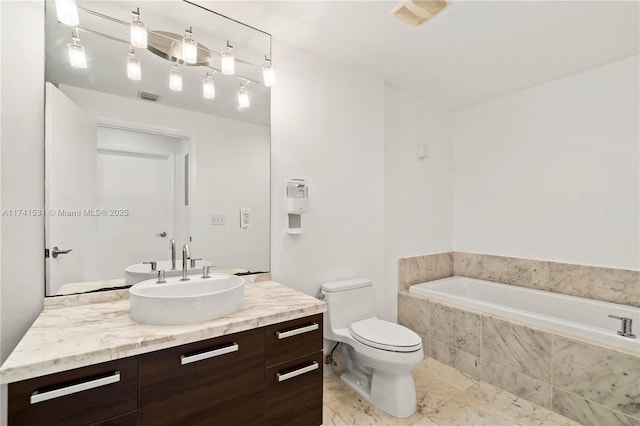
[{"left": 384, "top": 85, "right": 453, "bottom": 318}]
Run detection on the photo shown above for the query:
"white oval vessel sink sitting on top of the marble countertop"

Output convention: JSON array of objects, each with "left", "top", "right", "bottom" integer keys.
[{"left": 129, "top": 274, "right": 244, "bottom": 325}]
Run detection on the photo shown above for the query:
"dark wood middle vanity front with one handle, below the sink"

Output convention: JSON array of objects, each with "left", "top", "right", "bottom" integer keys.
[{"left": 139, "top": 328, "right": 265, "bottom": 426}]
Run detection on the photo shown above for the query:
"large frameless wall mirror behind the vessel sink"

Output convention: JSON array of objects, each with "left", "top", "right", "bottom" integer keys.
[{"left": 45, "top": 0, "right": 271, "bottom": 296}]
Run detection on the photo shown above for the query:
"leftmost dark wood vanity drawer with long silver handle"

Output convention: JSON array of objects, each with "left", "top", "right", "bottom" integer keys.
[{"left": 8, "top": 357, "right": 138, "bottom": 426}]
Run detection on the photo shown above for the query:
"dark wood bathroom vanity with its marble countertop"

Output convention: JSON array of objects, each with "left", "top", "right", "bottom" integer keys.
[{"left": 0, "top": 281, "right": 325, "bottom": 426}]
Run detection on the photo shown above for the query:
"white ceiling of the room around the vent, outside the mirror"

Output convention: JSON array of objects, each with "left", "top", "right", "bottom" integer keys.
[{"left": 197, "top": 0, "right": 640, "bottom": 110}]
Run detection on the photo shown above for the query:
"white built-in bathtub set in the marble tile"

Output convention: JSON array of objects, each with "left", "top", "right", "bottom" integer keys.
[{"left": 409, "top": 277, "right": 640, "bottom": 353}]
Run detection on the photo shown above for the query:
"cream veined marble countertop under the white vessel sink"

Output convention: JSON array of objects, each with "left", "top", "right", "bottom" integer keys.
[{"left": 0, "top": 281, "right": 326, "bottom": 384}]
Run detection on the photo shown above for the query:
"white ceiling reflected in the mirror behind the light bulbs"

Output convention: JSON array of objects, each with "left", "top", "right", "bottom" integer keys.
[{"left": 46, "top": 0, "right": 271, "bottom": 126}]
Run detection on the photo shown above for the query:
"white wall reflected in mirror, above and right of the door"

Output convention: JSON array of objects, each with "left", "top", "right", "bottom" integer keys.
[{"left": 63, "top": 86, "right": 270, "bottom": 271}]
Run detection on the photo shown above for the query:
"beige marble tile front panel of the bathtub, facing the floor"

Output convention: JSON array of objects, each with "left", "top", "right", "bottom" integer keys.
[{"left": 398, "top": 292, "right": 640, "bottom": 426}]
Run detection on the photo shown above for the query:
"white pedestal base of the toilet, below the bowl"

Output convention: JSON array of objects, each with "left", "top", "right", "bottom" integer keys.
[{"left": 340, "top": 371, "right": 416, "bottom": 418}]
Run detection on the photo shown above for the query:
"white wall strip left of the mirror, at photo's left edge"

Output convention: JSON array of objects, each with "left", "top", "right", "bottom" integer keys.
[{"left": 0, "top": 1, "right": 44, "bottom": 416}]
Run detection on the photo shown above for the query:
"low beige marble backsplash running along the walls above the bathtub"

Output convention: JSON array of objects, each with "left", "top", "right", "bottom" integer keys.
[{"left": 398, "top": 252, "right": 640, "bottom": 306}]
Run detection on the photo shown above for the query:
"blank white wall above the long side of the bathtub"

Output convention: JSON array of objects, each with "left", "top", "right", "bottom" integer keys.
[{"left": 454, "top": 56, "right": 640, "bottom": 269}]
